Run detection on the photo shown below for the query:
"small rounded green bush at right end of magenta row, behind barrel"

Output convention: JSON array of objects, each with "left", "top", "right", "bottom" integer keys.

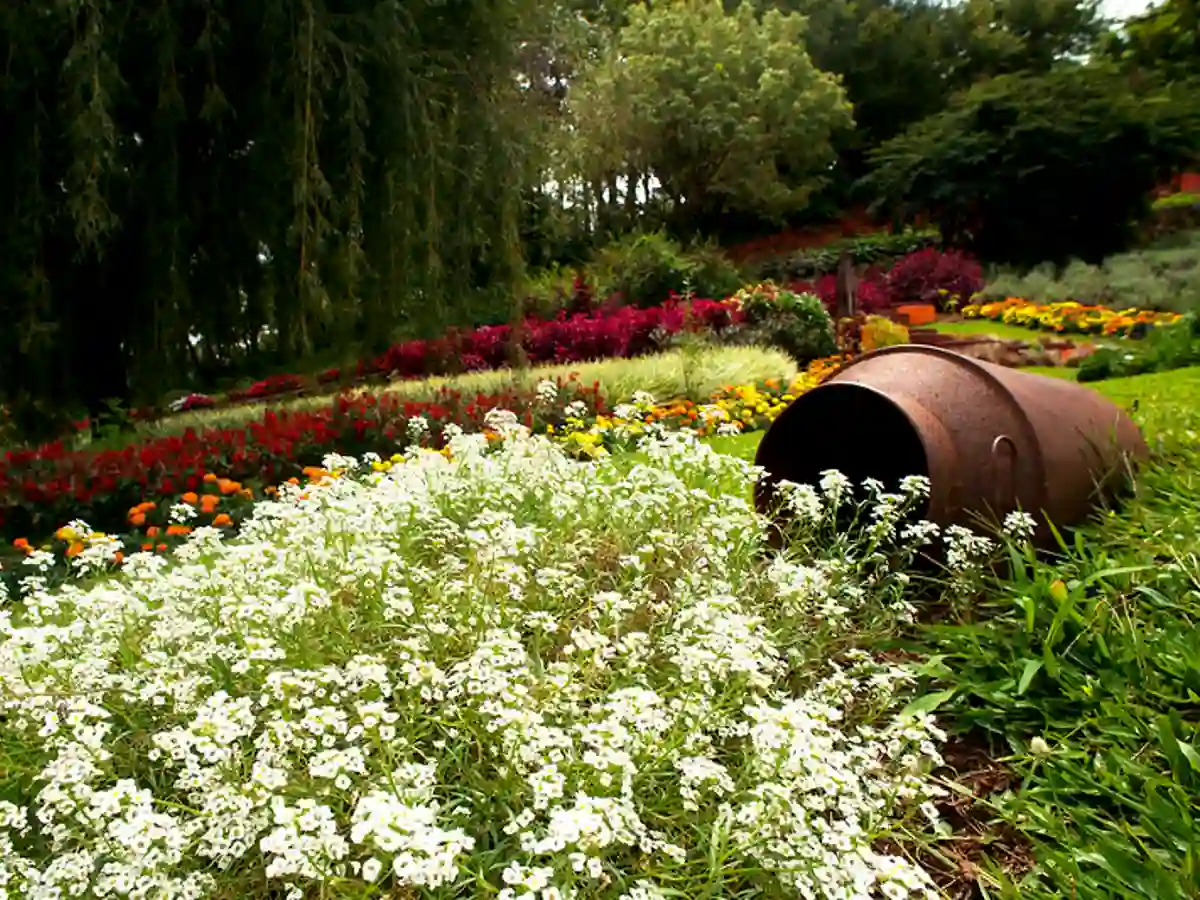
[{"left": 730, "top": 281, "right": 838, "bottom": 365}]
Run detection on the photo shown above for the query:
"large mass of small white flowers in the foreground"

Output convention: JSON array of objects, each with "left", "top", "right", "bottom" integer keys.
[{"left": 0, "top": 434, "right": 955, "bottom": 900}]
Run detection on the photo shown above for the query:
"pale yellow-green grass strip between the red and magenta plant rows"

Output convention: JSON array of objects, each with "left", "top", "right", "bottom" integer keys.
[{"left": 140, "top": 347, "right": 797, "bottom": 436}]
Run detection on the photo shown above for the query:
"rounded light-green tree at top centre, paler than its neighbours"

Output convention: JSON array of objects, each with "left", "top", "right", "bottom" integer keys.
[{"left": 569, "top": 0, "right": 851, "bottom": 236}]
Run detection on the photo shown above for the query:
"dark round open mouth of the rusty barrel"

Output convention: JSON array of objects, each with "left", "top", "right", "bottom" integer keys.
[{"left": 755, "top": 383, "right": 929, "bottom": 517}]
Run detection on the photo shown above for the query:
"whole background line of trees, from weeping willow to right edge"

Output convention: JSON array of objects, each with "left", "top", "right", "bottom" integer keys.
[{"left": 0, "top": 0, "right": 1200, "bottom": 433}]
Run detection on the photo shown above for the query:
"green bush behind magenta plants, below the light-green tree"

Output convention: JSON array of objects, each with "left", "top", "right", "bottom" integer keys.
[{"left": 590, "top": 232, "right": 742, "bottom": 306}]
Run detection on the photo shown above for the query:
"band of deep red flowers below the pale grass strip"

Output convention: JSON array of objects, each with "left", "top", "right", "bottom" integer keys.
[{"left": 0, "top": 383, "right": 602, "bottom": 541}]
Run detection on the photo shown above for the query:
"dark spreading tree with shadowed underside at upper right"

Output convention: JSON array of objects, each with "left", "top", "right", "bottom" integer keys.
[{"left": 864, "top": 65, "right": 1200, "bottom": 266}]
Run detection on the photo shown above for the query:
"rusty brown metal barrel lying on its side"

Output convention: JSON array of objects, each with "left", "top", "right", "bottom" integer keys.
[{"left": 755, "top": 344, "right": 1148, "bottom": 544}]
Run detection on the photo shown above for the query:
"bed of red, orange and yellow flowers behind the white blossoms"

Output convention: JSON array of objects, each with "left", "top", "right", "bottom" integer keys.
[{"left": 0, "top": 359, "right": 839, "bottom": 554}]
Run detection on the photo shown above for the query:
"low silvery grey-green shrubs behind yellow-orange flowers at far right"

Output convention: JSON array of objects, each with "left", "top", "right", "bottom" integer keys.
[{"left": 980, "top": 232, "right": 1200, "bottom": 313}]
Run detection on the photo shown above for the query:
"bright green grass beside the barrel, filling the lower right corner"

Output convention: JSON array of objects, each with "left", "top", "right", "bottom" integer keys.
[{"left": 712, "top": 368, "right": 1200, "bottom": 900}]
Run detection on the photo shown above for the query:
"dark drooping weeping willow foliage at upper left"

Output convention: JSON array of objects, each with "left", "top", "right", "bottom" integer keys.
[{"left": 0, "top": 0, "right": 534, "bottom": 436}]
